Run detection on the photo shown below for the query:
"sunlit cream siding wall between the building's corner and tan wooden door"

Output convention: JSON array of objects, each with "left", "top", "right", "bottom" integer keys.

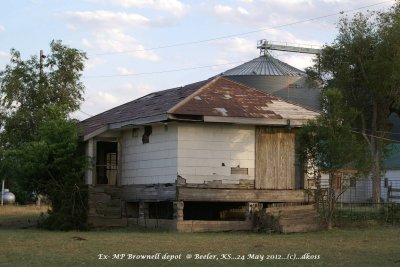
[{"left": 178, "top": 123, "right": 255, "bottom": 184}]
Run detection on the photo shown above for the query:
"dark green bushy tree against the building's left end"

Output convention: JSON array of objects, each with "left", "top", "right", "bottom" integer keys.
[{"left": 9, "top": 107, "right": 87, "bottom": 230}]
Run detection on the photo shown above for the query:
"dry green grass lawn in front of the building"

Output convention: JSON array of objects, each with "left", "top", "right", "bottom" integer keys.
[{"left": 0, "top": 206, "right": 400, "bottom": 266}]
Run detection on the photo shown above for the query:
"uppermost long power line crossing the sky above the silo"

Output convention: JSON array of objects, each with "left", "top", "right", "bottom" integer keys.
[{"left": 92, "top": 0, "right": 395, "bottom": 56}]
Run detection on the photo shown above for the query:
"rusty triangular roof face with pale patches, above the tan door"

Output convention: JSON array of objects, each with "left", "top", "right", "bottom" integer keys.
[{"left": 169, "top": 77, "right": 318, "bottom": 119}]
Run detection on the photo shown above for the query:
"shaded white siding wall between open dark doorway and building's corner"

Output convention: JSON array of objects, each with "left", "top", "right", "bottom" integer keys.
[{"left": 119, "top": 123, "right": 177, "bottom": 185}]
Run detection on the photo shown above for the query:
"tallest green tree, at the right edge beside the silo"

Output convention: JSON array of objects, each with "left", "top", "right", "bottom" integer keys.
[{"left": 308, "top": 2, "right": 400, "bottom": 203}]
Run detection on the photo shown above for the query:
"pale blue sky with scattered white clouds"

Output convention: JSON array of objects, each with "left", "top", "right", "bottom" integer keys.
[{"left": 0, "top": 0, "right": 395, "bottom": 120}]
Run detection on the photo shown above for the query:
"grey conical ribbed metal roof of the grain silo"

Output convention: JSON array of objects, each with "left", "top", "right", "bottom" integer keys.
[{"left": 222, "top": 53, "right": 306, "bottom": 77}]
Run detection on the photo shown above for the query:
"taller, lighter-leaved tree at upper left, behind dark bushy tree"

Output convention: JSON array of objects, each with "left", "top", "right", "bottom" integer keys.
[{"left": 0, "top": 41, "right": 86, "bottom": 148}]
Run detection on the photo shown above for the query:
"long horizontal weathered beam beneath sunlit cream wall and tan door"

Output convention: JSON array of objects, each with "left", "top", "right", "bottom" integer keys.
[{"left": 177, "top": 187, "right": 308, "bottom": 202}]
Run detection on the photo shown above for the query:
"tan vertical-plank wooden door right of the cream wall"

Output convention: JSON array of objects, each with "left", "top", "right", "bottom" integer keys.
[{"left": 255, "top": 127, "right": 295, "bottom": 189}]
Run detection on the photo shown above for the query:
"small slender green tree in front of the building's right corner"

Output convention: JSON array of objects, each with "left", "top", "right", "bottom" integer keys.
[{"left": 297, "top": 89, "right": 369, "bottom": 229}]
